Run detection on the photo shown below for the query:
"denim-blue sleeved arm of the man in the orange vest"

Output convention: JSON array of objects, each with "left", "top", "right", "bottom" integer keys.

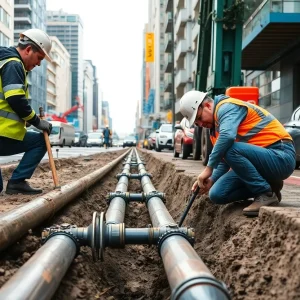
[{"left": 207, "top": 103, "right": 247, "bottom": 169}]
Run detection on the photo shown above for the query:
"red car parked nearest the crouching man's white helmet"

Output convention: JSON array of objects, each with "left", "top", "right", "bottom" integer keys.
[{"left": 174, "top": 118, "right": 194, "bottom": 159}]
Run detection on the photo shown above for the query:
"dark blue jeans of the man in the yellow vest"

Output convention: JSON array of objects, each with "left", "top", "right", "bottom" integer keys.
[{"left": 0, "top": 131, "right": 47, "bottom": 191}]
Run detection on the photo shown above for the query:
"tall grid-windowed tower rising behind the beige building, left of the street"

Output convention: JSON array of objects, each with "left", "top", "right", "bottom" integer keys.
[{"left": 47, "top": 10, "right": 83, "bottom": 124}]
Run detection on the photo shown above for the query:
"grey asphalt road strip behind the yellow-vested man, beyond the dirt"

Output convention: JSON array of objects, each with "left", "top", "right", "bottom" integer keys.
[{"left": 0, "top": 147, "right": 123, "bottom": 165}]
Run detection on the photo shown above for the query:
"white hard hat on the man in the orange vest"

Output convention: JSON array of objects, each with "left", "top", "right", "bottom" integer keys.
[{"left": 179, "top": 91, "right": 207, "bottom": 126}]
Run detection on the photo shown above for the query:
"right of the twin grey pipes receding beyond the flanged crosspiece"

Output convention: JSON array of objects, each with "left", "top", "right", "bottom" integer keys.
[{"left": 135, "top": 150, "right": 177, "bottom": 227}]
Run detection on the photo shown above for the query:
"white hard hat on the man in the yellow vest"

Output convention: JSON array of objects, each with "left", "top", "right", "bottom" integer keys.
[{"left": 19, "top": 29, "right": 52, "bottom": 62}]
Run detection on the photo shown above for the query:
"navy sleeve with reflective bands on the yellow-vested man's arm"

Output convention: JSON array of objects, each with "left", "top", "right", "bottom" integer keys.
[{"left": 1, "top": 61, "right": 40, "bottom": 126}]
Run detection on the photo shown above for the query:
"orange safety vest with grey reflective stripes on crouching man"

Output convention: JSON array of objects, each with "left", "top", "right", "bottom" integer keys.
[{"left": 210, "top": 98, "right": 292, "bottom": 147}]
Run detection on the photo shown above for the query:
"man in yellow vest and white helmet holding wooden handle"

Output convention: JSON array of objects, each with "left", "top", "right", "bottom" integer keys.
[{"left": 0, "top": 29, "right": 52, "bottom": 194}]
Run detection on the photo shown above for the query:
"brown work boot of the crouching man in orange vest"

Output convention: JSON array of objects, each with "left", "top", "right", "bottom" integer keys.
[{"left": 243, "top": 192, "right": 279, "bottom": 217}]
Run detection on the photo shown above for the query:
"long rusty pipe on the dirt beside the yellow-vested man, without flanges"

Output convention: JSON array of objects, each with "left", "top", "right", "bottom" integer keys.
[{"left": 0, "top": 150, "right": 130, "bottom": 251}]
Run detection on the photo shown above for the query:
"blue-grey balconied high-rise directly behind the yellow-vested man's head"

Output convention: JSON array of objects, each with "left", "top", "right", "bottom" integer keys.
[{"left": 14, "top": 0, "right": 47, "bottom": 112}]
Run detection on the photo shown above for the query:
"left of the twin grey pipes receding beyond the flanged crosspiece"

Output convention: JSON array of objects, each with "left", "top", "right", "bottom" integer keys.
[{"left": 105, "top": 150, "right": 133, "bottom": 224}]
